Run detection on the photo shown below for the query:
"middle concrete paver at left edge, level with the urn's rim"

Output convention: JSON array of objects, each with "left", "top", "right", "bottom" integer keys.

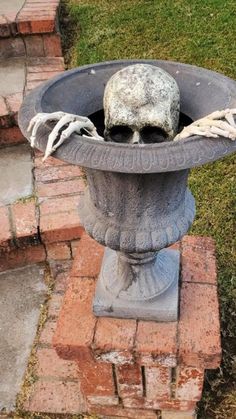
[{"left": 0, "top": 144, "right": 33, "bottom": 205}]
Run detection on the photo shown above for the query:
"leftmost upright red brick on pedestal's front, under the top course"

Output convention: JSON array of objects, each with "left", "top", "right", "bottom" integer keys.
[{"left": 77, "top": 353, "right": 115, "bottom": 404}]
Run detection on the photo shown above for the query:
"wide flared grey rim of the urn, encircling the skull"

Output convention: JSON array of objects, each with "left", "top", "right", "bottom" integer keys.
[{"left": 18, "top": 60, "right": 236, "bottom": 173}]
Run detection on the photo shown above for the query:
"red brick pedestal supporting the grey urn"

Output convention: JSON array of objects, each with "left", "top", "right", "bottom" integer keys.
[{"left": 54, "top": 235, "right": 221, "bottom": 419}]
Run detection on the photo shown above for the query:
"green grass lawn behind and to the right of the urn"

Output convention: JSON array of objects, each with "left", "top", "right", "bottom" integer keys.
[{"left": 62, "top": 0, "right": 236, "bottom": 419}]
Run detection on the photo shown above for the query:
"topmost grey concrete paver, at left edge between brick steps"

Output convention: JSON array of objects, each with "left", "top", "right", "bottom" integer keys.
[{"left": 0, "top": 58, "right": 25, "bottom": 97}]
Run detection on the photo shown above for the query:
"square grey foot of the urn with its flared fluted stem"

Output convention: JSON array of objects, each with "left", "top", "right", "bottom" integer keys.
[{"left": 93, "top": 248, "right": 180, "bottom": 322}]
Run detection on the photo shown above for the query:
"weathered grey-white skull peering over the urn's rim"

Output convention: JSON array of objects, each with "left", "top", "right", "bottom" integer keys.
[{"left": 103, "top": 64, "right": 180, "bottom": 144}]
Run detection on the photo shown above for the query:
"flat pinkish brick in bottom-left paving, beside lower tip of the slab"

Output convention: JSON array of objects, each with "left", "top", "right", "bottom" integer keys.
[{"left": 24, "top": 380, "right": 86, "bottom": 414}]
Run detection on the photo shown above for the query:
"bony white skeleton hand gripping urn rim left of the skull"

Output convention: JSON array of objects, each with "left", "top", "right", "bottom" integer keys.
[{"left": 27, "top": 112, "right": 103, "bottom": 161}]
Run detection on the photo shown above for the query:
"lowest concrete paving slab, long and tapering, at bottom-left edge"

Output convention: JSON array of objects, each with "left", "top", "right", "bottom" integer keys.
[{"left": 0, "top": 265, "right": 46, "bottom": 412}]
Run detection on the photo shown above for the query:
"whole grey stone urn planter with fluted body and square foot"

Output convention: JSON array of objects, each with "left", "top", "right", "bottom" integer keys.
[{"left": 19, "top": 60, "right": 236, "bottom": 321}]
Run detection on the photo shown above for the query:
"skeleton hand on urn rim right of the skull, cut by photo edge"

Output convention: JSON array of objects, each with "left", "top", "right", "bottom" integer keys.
[{"left": 174, "top": 108, "right": 236, "bottom": 141}]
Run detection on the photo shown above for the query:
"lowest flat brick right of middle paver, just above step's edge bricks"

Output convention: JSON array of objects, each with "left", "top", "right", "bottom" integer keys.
[{"left": 40, "top": 197, "right": 79, "bottom": 217}]
